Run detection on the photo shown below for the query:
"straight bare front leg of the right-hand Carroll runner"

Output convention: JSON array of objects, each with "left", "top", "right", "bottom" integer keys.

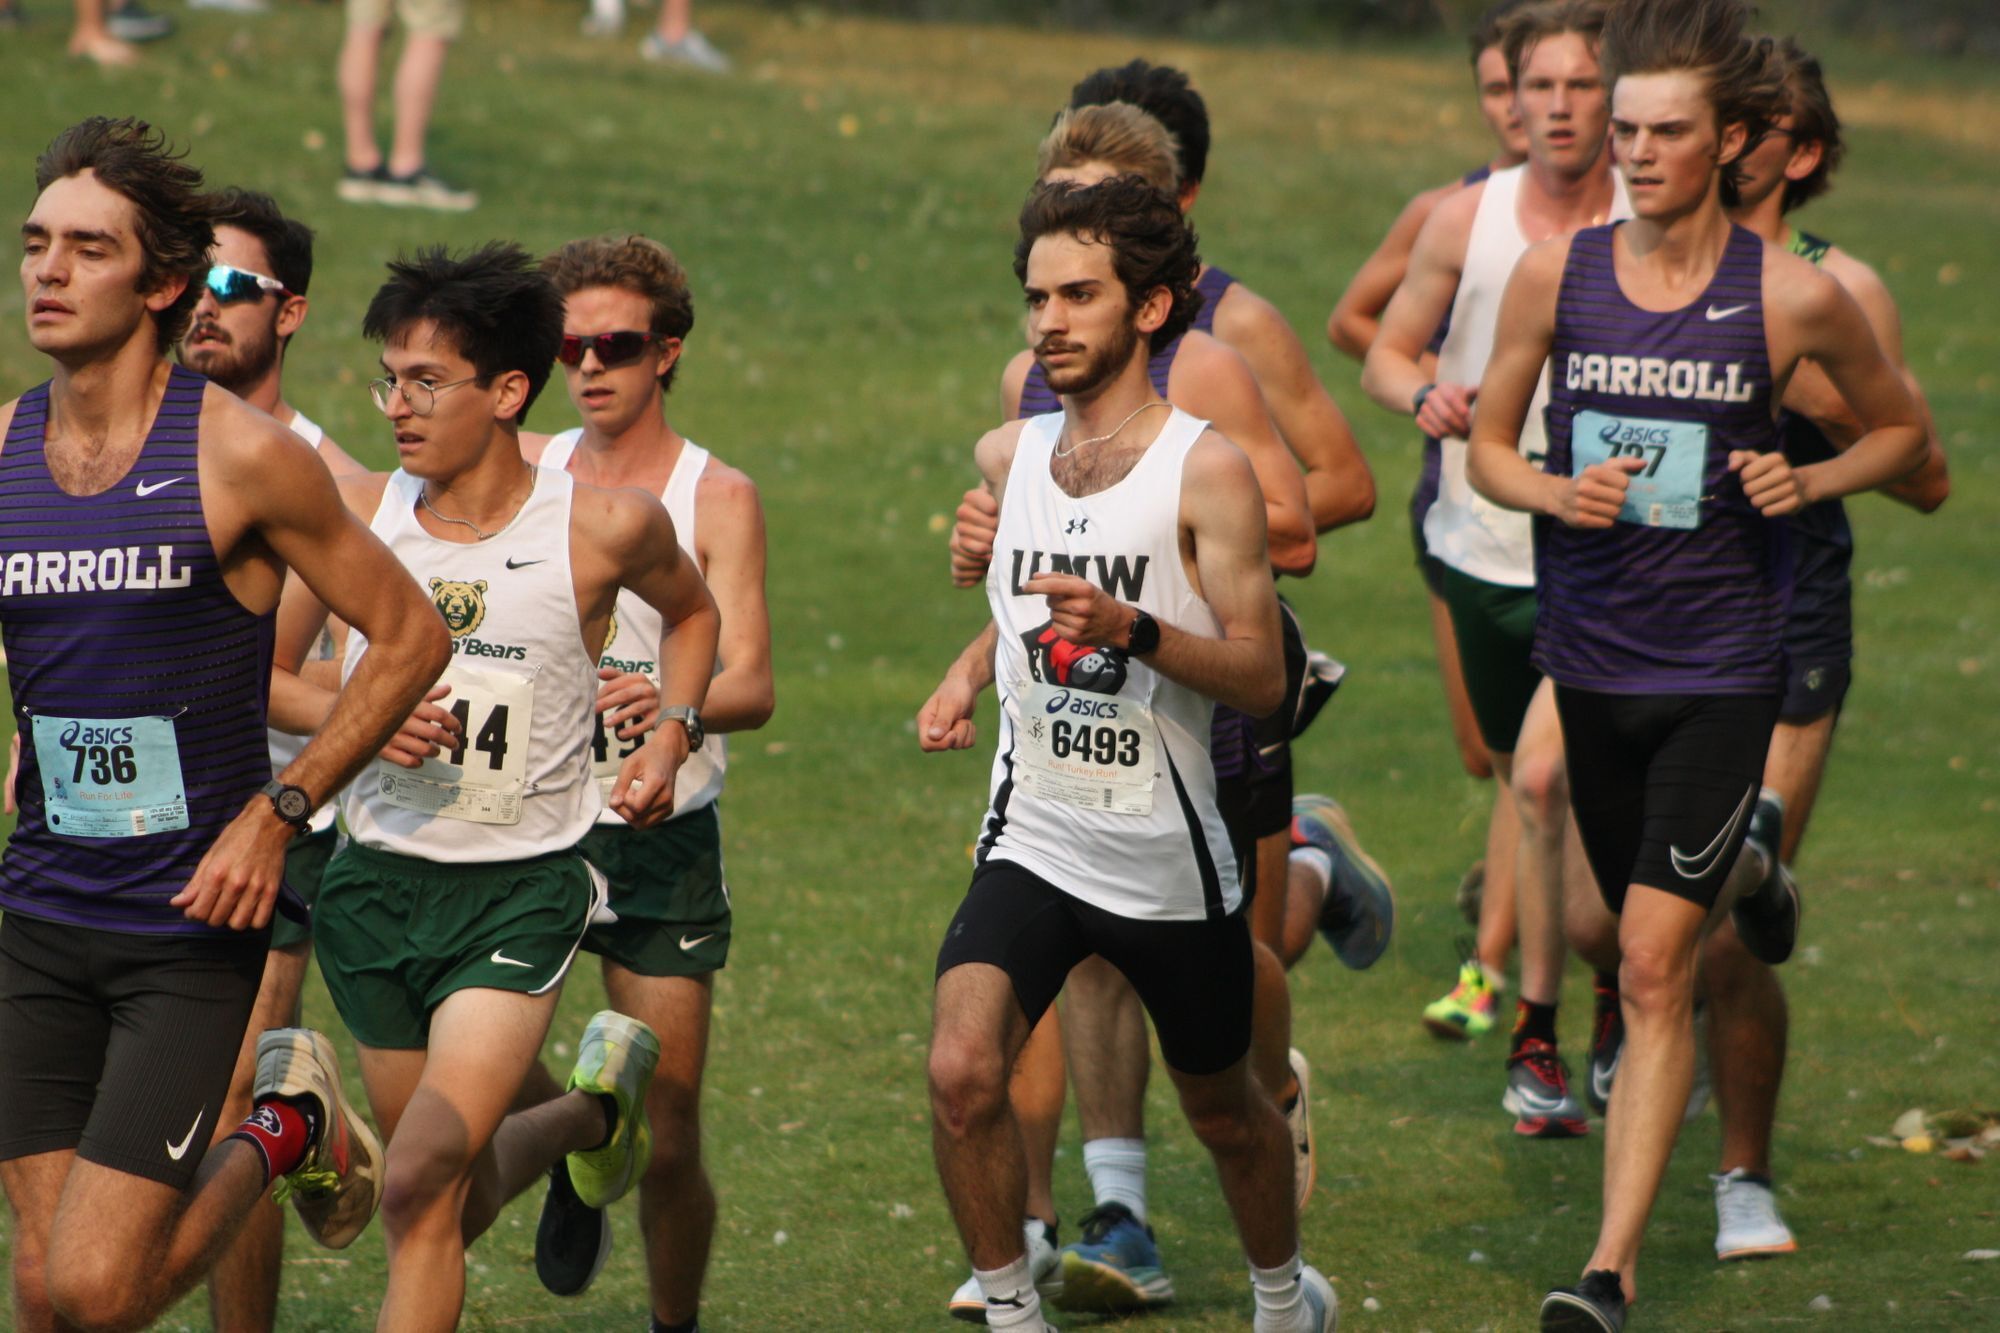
[{"left": 1586, "top": 885, "right": 1706, "bottom": 1299}]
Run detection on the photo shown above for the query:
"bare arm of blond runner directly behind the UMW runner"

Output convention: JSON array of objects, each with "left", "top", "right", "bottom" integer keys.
[{"left": 1168, "top": 332, "right": 1320, "bottom": 576}]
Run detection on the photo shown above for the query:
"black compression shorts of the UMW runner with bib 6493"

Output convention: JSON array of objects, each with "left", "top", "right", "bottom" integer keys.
[{"left": 938, "top": 859, "right": 1252, "bottom": 1075}]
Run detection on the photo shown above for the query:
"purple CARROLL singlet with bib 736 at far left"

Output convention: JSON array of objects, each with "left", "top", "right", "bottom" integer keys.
[{"left": 0, "top": 366, "right": 276, "bottom": 935}]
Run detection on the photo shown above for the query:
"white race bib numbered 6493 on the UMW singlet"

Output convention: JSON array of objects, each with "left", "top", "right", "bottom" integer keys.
[{"left": 1014, "top": 681, "right": 1160, "bottom": 815}]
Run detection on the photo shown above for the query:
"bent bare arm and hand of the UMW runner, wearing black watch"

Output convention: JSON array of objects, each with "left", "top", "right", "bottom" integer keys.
[{"left": 1024, "top": 432, "right": 1284, "bottom": 717}]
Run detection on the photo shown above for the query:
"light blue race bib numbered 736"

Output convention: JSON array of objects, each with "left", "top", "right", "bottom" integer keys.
[{"left": 30, "top": 715, "right": 188, "bottom": 839}]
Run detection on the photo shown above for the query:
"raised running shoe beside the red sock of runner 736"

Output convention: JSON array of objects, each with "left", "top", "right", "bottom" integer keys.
[{"left": 252, "top": 1027, "right": 382, "bottom": 1249}]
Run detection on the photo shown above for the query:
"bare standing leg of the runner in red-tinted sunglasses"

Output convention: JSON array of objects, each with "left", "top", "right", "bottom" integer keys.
[{"left": 604, "top": 963, "right": 716, "bottom": 1323}]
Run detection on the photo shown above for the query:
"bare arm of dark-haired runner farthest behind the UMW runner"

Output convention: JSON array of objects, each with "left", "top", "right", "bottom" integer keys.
[{"left": 1216, "top": 282, "right": 1376, "bottom": 532}]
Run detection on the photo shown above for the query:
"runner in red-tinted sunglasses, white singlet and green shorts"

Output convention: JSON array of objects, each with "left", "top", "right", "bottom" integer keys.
[{"left": 524, "top": 236, "right": 776, "bottom": 1333}]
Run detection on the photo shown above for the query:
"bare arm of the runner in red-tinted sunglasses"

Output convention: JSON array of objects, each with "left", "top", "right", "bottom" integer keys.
[{"left": 696, "top": 462, "right": 778, "bottom": 733}]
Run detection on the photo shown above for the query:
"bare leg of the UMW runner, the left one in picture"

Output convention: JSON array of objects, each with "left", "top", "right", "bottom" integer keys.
[{"left": 930, "top": 963, "right": 1028, "bottom": 1271}]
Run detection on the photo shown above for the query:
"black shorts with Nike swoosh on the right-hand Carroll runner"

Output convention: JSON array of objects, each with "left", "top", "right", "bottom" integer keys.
[{"left": 1556, "top": 685, "right": 1778, "bottom": 913}]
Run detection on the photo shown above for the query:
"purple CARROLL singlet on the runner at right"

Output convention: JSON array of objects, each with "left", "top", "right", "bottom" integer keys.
[{"left": 1534, "top": 224, "right": 1790, "bottom": 695}]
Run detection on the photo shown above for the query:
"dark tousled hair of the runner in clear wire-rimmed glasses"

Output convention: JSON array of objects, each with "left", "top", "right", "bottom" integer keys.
[{"left": 362, "top": 240, "right": 562, "bottom": 424}]
